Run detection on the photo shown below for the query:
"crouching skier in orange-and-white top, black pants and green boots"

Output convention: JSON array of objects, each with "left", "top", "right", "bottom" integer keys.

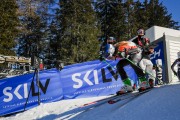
[{"left": 115, "top": 41, "right": 145, "bottom": 95}]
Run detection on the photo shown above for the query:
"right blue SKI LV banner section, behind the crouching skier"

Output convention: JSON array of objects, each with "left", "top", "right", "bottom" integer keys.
[{"left": 61, "top": 60, "right": 137, "bottom": 99}]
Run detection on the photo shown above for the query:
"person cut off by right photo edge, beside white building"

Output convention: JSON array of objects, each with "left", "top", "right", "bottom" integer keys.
[{"left": 171, "top": 52, "right": 180, "bottom": 81}]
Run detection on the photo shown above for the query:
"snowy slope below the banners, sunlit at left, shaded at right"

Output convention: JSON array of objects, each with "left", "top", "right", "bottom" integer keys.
[{"left": 1, "top": 82, "right": 180, "bottom": 120}]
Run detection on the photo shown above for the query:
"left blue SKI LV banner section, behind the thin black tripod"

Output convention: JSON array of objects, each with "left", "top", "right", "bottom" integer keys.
[{"left": 0, "top": 69, "right": 63, "bottom": 115}]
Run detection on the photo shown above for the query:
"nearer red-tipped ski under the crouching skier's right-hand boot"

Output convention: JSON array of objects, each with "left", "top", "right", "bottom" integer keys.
[{"left": 108, "top": 89, "right": 151, "bottom": 104}]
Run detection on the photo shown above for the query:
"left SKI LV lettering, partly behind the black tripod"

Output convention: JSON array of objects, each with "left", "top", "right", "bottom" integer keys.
[{"left": 3, "top": 79, "right": 50, "bottom": 102}]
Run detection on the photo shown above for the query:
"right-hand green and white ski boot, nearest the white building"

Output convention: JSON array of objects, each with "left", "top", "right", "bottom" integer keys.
[{"left": 139, "top": 77, "right": 150, "bottom": 92}]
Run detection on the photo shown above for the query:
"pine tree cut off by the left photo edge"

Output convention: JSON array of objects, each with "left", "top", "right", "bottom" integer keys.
[{"left": 0, "top": 0, "right": 19, "bottom": 55}]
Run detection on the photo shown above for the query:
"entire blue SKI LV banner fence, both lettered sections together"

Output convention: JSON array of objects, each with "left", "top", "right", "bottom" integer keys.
[{"left": 0, "top": 60, "right": 137, "bottom": 116}]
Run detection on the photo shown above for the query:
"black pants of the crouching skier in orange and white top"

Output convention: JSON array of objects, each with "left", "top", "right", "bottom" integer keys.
[{"left": 116, "top": 59, "right": 145, "bottom": 80}]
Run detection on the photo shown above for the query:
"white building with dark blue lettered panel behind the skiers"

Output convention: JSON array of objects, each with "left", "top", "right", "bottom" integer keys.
[{"left": 145, "top": 26, "right": 180, "bottom": 83}]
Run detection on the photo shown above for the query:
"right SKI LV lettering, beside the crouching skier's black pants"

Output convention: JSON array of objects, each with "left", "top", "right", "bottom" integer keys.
[{"left": 72, "top": 67, "right": 118, "bottom": 89}]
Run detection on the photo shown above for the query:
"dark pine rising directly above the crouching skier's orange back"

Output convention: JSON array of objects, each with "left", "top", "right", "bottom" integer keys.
[{"left": 96, "top": 0, "right": 126, "bottom": 41}]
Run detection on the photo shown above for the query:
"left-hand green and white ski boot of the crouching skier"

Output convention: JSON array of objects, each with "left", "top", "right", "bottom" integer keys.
[{"left": 116, "top": 78, "right": 133, "bottom": 95}]
